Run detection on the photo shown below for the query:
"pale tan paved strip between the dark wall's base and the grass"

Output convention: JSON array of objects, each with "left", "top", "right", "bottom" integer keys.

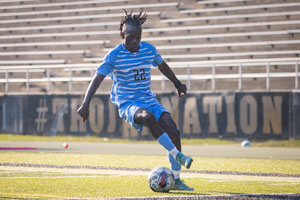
[{"left": 0, "top": 141, "right": 300, "bottom": 160}]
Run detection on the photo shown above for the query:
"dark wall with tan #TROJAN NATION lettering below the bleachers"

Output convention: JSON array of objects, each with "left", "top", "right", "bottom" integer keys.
[{"left": 0, "top": 92, "right": 300, "bottom": 139}]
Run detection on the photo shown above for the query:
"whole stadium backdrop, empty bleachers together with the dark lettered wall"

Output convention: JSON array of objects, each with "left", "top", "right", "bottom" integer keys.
[{"left": 0, "top": 0, "right": 300, "bottom": 139}]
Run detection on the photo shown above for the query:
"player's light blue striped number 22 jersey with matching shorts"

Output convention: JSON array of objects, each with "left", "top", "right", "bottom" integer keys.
[{"left": 97, "top": 42, "right": 166, "bottom": 128}]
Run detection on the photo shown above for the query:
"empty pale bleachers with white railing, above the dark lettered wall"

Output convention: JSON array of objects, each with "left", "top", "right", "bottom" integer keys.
[{"left": 0, "top": 0, "right": 300, "bottom": 93}]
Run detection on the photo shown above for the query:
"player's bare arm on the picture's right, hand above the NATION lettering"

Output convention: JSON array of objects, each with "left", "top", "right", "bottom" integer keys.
[{"left": 158, "top": 61, "right": 186, "bottom": 97}]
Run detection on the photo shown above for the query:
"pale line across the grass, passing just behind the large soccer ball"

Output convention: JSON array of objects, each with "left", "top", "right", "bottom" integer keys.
[{"left": 0, "top": 166, "right": 300, "bottom": 183}]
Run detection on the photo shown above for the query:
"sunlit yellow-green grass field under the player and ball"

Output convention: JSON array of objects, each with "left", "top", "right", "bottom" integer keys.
[{"left": 0, "top": 135, "right": 300, "bottom": 199}]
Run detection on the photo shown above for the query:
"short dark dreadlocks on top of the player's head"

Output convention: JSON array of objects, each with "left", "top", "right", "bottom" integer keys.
[{"left": 119, "top": 9, "right": 148, "bottom": 31}]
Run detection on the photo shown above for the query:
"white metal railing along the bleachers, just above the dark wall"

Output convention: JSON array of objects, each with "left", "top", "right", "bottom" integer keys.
[{"left": 0, "top": 58, "right": 300, "bottom": 93}]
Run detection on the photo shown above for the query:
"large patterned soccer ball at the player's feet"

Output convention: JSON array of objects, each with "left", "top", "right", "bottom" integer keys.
[{"left": 148, "top": 167, "right": 175, "bottom": 192}]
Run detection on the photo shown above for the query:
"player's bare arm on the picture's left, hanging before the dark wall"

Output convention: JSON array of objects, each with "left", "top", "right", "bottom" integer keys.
[{"left": 77, "top": 73, "right": 105, "bottom": 122}]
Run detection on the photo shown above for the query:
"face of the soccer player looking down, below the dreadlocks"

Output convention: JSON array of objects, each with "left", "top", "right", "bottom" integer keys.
[{"left": 122, "top": 24, "right": 142, "bottom": 52}]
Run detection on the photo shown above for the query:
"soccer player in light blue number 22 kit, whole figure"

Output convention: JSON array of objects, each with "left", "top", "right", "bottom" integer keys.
[{"left": 77, "top": 10, "right": 194, "bottom": 190}]
